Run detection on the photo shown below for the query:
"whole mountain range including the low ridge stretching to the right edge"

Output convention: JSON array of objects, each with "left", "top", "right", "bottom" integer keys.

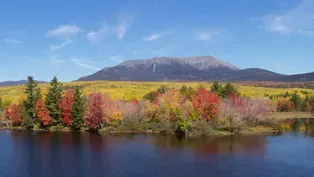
[{"left": 78, "top": 56, "right": 314, "bottom": 82}]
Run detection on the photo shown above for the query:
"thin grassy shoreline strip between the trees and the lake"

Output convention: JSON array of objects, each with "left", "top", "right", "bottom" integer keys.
[{"left": 0, "top": 112, "right": 314, "bottom": 137}]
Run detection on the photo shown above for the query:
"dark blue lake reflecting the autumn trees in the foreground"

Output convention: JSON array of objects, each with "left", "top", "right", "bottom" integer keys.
[{"left": 0, "top": 119, "right": 314, "bottom": 177}]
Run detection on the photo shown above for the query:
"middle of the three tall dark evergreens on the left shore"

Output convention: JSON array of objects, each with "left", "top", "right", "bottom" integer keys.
[{"left": 45, "top": 76, "right": 63, "bottom": 125}]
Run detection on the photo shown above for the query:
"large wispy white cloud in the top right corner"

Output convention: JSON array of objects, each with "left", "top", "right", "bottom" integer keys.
[{"left": 264, "top": 0, "right": 314, "bottom": 36}]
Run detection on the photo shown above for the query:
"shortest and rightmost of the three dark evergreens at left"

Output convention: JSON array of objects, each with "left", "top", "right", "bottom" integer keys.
[{"left": 71, "top": 87, "right": 84, "bottom": 130}]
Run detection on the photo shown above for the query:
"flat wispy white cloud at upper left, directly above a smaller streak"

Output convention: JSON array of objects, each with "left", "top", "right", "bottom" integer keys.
[{"left": 46, "top": 25, "right": 83, "bottom": 38}]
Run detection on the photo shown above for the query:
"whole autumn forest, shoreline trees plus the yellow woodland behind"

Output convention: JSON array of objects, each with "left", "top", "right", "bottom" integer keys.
[{"left": 0, "top": 76, "right": 314, "bottom": 136}]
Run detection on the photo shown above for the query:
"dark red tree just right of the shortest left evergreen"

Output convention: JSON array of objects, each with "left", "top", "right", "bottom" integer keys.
[{"left": 85, "top": 93, "right": 104, "bottom": 130}]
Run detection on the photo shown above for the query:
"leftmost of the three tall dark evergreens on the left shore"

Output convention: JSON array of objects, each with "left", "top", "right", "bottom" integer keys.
[{"left": 22, "top": 76, "right": 38, "bottom": 128}]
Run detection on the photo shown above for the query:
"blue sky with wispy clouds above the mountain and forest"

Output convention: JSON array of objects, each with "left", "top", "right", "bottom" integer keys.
[{"left": 0, "top": 0, "right": 314, "bottom": 81}]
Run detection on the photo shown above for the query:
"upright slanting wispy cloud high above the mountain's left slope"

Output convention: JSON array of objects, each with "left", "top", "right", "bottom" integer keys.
[{"left": 114, "top": 14, "right": 134, "bottom": 39}]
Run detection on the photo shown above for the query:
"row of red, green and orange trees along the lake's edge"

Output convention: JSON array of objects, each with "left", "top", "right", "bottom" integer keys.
[{"left": 0, "top": 76, "right": 280, "bottom": 134}]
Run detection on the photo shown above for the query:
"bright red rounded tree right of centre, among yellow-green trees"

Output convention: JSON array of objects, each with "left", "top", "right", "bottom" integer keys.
[{"left": 192, "top": 88, "right": 220, "bottom": 120}]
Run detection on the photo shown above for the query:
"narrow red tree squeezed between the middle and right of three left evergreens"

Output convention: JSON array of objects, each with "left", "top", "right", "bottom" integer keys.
[{"left": 59, "top": 89, "right": 74, "bottom": 126}]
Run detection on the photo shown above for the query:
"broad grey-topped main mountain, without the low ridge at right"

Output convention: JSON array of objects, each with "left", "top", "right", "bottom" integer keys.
[{"left": 78, "top": 56, "right": 240, "bottom": 81}]
